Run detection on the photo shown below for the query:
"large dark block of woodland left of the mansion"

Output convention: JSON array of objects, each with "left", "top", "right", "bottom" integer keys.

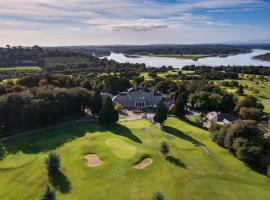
[{"left": 0, "top": 86, "right": 102, "bottom": 132}]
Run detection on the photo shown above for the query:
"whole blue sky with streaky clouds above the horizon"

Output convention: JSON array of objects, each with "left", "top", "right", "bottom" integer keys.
[{"left": 0, "top": 0, "right": 270, "bottom": 46}]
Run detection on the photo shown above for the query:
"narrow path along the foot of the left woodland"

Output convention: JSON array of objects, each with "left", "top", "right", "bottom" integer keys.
[{"left": 0, "top": 118, "right": 95, "bottom": 143}]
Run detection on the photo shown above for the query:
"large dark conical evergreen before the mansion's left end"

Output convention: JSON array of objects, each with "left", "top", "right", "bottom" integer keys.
[{"left": 99, "top": 97, "right": 119, "bottom": 124}]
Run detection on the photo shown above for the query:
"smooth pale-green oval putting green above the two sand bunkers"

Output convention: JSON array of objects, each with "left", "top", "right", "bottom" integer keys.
[{"left": 105, "top": 138, "right": 137, "bottom": 159}]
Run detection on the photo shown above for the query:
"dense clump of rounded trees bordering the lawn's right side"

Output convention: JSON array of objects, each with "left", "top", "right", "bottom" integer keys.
[{"left": 211, "top": 120, "right": 270, "bottom": 172}]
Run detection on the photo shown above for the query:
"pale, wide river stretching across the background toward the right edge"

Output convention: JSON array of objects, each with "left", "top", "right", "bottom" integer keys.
[{"left": 106, "top": 49, "right": 270, "bottom": 68}]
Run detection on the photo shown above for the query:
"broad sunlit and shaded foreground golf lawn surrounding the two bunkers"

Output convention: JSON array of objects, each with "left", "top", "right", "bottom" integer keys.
[{"left": 0, "top": 117, "right": 270, "bottom": 200}]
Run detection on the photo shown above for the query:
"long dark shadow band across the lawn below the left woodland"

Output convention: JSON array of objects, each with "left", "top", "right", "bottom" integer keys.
[{"left": 0, "top": 122, "right": 142, "bottom": 156}]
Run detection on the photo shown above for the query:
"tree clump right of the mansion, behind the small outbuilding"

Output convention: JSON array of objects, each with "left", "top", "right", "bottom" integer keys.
[{"left": 152, "top": 78, "right": 236, "bottom": 118}]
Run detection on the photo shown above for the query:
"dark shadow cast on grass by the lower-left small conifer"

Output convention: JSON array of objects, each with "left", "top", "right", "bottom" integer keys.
[{"left": 49, "top": 171, "right": 71, "bottom": 194}]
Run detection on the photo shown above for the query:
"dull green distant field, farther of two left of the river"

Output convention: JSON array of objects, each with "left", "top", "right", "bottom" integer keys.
[{"left": 44, "top": 56, "right": 89, "bottom": 67}]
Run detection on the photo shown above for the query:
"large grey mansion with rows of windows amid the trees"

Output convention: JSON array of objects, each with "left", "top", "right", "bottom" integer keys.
[{"left": 113, "top": 87, "right": 171, "bottom": 108}]
